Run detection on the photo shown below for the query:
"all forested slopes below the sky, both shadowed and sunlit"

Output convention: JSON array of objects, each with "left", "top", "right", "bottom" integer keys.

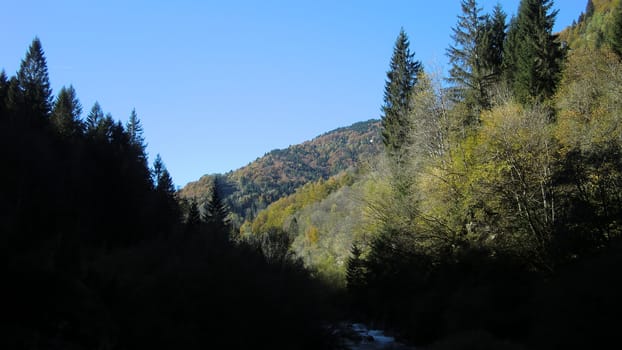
[{"left": 0, "top": 0, "right": 622, "bottom": 349}]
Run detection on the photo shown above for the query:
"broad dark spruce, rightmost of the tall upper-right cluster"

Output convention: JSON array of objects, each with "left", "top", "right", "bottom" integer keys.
[{"left": 505, "top": 0, "right": 565, "bottom": 102}]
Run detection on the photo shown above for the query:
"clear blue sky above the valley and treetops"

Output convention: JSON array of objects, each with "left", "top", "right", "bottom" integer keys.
[{"left": 0, "top": 0, "right": 587, "bottom": 186}]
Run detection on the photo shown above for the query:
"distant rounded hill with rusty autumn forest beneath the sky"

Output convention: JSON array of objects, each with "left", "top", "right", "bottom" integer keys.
[{"left": 180, "top": 119, "right": 382, "bottom": 224}]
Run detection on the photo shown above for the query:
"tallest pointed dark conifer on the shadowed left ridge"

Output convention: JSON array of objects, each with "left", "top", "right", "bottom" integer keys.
[{"left": 17, "top": 37, "right": 52, "bottom": 123}]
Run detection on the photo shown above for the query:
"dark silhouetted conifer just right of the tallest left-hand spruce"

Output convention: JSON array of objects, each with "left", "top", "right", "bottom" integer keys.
[{"left": 51, "top": 85, "right": 83, "bottom": 137}]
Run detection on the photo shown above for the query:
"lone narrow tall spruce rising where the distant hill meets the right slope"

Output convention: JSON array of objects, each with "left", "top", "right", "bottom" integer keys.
[{"left": 382, "top": 29, "right": 422, "bottom": 159}]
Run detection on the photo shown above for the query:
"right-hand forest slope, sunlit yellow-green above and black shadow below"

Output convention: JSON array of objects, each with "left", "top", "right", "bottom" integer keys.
[{"left": 241, "top": 0, "right": 622, "bottom": 349}]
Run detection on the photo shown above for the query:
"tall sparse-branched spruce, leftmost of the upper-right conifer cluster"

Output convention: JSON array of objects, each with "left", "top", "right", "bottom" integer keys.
[{"left": 447, "top": 0, "right": 488, "bottom": 115}]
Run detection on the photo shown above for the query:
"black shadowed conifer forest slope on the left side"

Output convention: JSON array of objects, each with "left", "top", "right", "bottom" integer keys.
[{"left": 0, "top": 38, "right": 332, "bottom": 349}]
